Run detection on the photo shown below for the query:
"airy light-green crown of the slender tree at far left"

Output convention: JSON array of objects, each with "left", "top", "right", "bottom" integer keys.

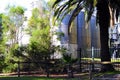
[{"left": 2, "top": 7, "right": 24, "bottom": 43}]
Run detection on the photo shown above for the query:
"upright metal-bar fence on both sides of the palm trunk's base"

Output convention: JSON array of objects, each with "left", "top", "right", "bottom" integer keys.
[{"left": 80, "top": 47, "right": 120, "bottom": 72}]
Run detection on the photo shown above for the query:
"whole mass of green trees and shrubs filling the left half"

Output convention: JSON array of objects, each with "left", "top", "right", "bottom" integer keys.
[{"left": 0, "top": 0, "right": 55, "bottom": 72}]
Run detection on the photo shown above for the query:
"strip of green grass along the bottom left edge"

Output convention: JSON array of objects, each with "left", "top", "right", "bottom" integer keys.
[{"left": 0, "top": 77, "right": 65, "bottom": 80}]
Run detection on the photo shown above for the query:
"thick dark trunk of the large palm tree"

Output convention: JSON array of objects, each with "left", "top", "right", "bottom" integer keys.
[{"left": 97, "top": 0, "right": 114, "bottom": 71}]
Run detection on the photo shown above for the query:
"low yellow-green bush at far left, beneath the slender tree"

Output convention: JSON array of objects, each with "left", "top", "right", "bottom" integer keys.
[{"left": 2, "top": 44, "right": 18, "bottom": 72}]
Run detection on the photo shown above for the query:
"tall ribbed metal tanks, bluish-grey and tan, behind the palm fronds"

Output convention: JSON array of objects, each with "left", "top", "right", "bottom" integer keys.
[{"left": 60, "top": 11, "right": 100, "bottom": 57}]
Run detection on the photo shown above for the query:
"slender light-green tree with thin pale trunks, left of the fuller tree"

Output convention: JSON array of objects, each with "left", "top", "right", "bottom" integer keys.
[{"left": 4, "top": 6, "right": 24, "bottom": 46}]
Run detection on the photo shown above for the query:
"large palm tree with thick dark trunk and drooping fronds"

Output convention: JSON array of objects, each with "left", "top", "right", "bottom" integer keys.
[{"left": 53, "top": 0, "right": 120, "bottom": 71}]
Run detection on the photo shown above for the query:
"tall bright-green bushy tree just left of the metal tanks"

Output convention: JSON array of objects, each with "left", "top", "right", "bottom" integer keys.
[{"left": 28, "top": 5, "right": 52, "bottom": 61}]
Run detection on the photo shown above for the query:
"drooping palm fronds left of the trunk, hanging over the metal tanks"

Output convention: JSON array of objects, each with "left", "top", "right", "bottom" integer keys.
[{"left": 53, "top": 0, "right": 97, "bottom": 30}]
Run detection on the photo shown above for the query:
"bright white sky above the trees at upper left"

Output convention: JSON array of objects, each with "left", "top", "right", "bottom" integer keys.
[{"left": 0, "top": 0, "right": 48, "bottom": 13}]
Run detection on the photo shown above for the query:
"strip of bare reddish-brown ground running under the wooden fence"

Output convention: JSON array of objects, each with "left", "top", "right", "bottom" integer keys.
[{"left": 0, "top": 73, "right": 120, "bottom": 80}]
